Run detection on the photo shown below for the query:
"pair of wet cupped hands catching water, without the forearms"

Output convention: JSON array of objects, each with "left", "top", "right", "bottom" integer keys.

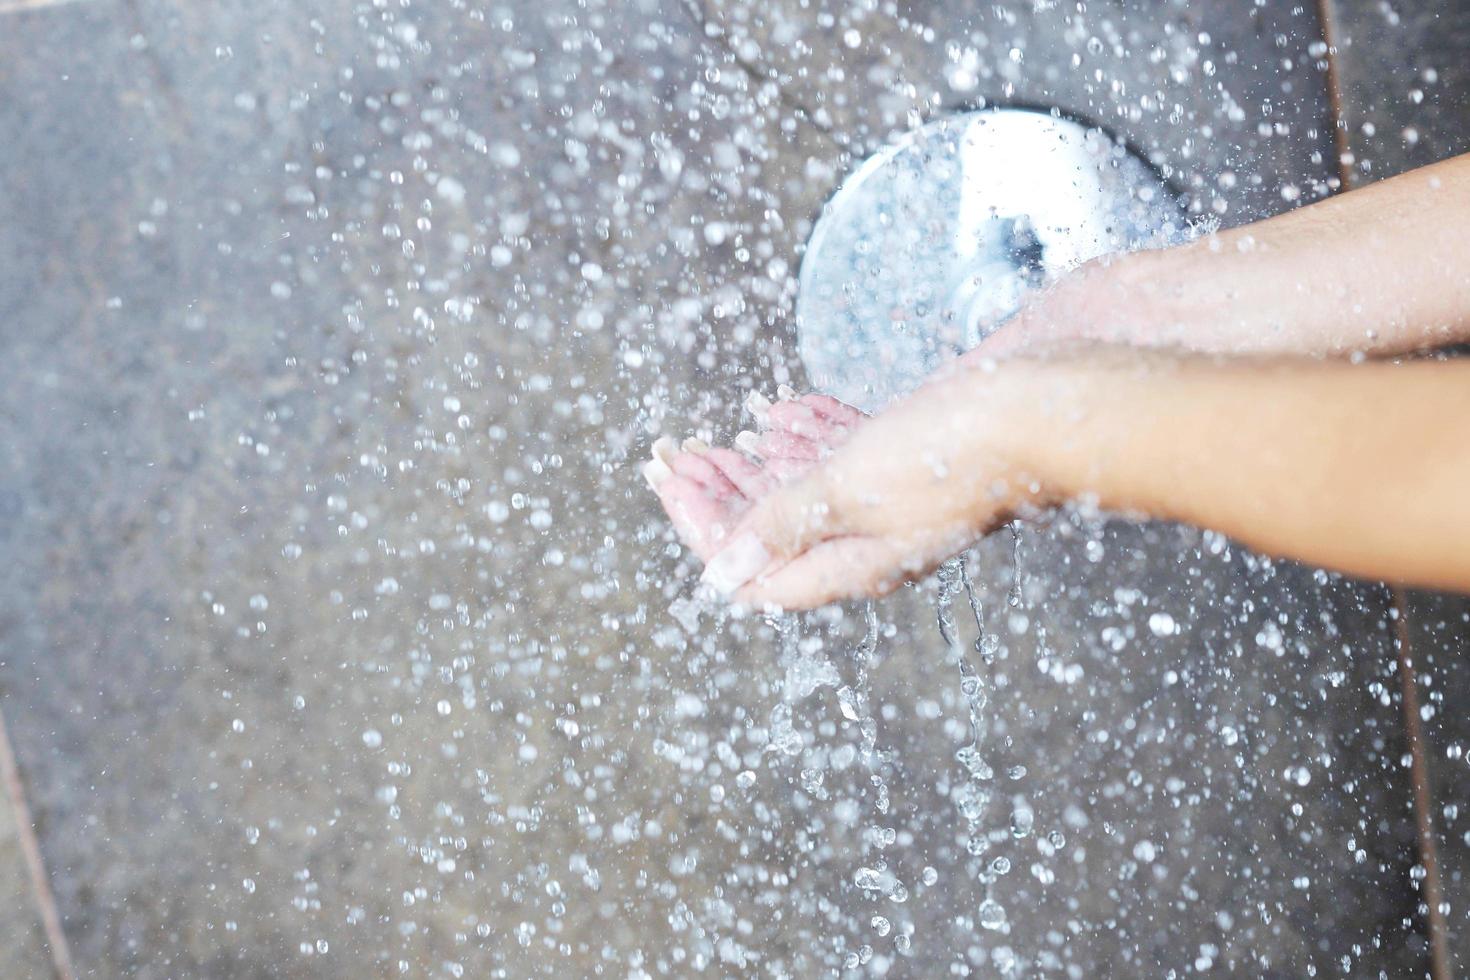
[{"left": 644, "top": 263, "right": 1116, "bottom": 608}]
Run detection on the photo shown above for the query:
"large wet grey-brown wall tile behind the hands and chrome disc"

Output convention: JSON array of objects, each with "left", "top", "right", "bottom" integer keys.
[{"left": 0, "top": 0, "right": 1423, "bottom": 977}]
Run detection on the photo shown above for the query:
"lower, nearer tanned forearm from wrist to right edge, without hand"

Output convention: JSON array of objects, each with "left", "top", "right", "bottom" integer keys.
[{"left": 988, "top": 360, "right": 1470, "bottom": 589}]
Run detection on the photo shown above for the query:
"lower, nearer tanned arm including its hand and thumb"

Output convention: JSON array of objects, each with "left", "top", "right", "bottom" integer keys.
[{"left": 706, "top": 353, "right": 1470, "bottom": 607}]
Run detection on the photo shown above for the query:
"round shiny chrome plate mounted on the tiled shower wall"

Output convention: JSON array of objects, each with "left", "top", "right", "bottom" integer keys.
[{"left": 797, "top": 109, "right": 1186, "bottom": 411}]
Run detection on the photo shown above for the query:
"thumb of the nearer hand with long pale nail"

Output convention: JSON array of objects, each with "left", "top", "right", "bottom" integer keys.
[{"left": 700, "top": 467, "right": 842, "bottom": 595}]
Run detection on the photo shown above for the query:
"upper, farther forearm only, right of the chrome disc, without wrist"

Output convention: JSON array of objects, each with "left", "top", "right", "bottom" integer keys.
[{"left": 1158, "top": 157, "right": 1470, "bottom": 354}]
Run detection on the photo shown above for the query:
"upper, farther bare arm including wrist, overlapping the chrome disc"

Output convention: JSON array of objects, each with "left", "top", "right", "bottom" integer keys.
[{"left": 970, "top": 156, "right": 1470, "bottom": 360}]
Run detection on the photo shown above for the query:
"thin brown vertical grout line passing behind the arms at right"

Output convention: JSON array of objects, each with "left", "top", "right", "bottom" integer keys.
[{"left": 1317, "top": 0, "right": 1451, "bottom": 980}]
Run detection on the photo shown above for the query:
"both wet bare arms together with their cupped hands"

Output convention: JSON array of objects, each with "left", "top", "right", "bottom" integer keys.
[{"left": 644, "top": 157, "right": 1470, "bottom": 608}]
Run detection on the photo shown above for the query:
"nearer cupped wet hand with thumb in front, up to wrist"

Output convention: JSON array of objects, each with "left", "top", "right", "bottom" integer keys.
[{"left": 676, "top": 369, "right": 1045, "bottom": 608}]
